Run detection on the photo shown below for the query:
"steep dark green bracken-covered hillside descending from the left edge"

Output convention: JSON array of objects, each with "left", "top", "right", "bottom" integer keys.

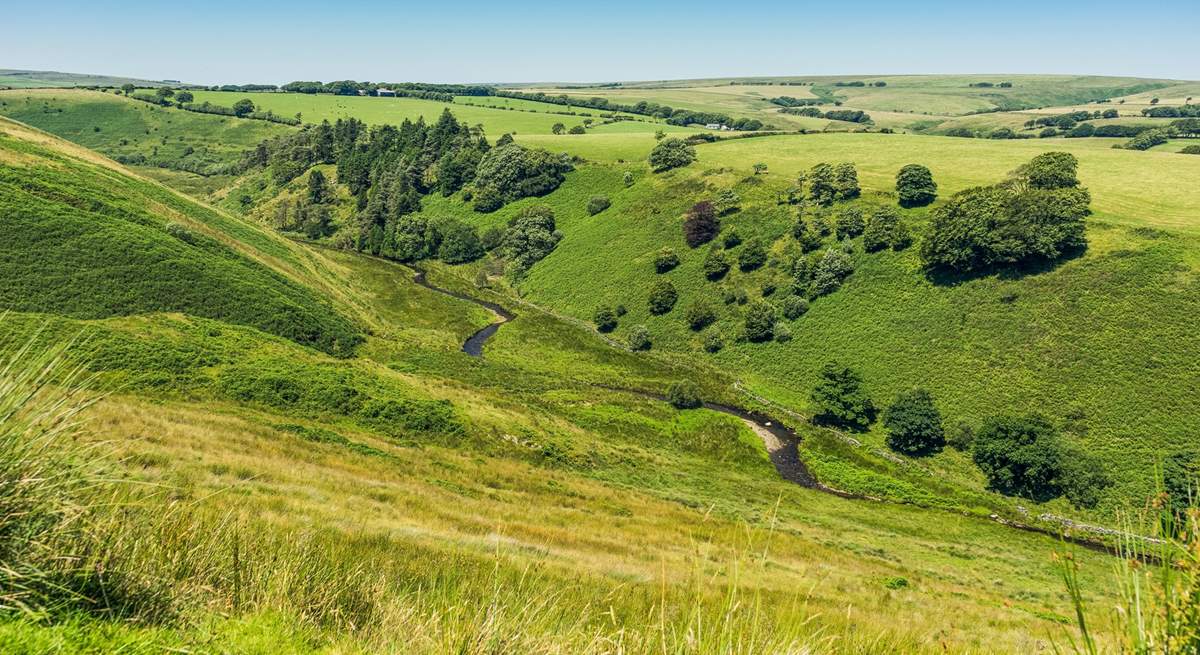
[{"left": 0, "top": 114, "right": 362, "bottom": 355}]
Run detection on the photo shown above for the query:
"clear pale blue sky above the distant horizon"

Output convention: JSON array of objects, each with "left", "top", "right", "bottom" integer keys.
[{"left": 0, "top": 0, "right": 1200, "bottom": 84}]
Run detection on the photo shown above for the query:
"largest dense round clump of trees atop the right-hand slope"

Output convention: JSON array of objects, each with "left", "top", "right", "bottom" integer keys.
[{"left": 920, "top": 152, "right": 1091, "bottom": 272}]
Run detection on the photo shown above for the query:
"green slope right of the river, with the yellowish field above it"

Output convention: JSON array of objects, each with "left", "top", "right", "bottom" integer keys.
[{"left": 426, "top": 134, "right": 1200, "bottom": 501}]
